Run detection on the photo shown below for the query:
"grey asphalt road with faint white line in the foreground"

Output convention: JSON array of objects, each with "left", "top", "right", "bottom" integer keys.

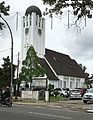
[{"left": 0, "top": 105, "right": 93, "bottom": 120}]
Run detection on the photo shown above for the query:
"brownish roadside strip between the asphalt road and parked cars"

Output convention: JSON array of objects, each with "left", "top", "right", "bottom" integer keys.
[{"left": 14, "top": 100, "right": 93, "bottom": 112}]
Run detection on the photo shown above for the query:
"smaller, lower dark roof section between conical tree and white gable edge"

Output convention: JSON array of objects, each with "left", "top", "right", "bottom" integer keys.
[{"left": 39, "top": 58, "right": 59, "bottom": 80}]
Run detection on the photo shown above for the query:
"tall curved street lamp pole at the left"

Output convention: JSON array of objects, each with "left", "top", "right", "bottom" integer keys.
[{"left": 0, "top": 14, "right": 13, "bottom": 96}]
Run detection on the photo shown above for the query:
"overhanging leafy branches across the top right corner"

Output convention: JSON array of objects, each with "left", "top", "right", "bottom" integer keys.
[{"left": 42, "top": 0, "right": 93, "bottom": 21}]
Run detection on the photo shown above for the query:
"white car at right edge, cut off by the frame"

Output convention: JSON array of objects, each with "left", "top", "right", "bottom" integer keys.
[{"left": 83, "top": 88, "right": 93, "bottom": 103}]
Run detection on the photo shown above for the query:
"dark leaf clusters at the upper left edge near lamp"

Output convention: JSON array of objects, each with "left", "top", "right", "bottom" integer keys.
[{"left": 0, "top": 1, "right": 10, "bottom": 30}]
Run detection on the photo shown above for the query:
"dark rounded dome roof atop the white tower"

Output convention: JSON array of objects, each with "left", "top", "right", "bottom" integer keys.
[{"left": 25, "top": 6, "right": 42, "bottom": 17}]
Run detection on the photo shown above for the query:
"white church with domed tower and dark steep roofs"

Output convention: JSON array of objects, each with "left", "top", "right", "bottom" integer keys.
[{"left": 21, "top": 6, "right": 85, "bottom": 89}]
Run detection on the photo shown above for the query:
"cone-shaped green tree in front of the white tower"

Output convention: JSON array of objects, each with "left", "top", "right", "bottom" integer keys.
[{"left": 19, "top": 46, "right": 45, "bottom": 87}]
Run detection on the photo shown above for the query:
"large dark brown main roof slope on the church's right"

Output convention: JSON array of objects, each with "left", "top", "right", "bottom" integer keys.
[{"left": 45, "top": 49, "right": 85, "bottom": 78}]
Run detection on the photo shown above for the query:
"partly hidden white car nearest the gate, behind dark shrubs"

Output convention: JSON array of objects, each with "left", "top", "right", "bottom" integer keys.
[{"left": 54, "top": 88, "right": 69, "bottom": 97}]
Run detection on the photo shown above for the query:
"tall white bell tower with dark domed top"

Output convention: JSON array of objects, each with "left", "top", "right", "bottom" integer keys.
[{"left": 22, "top": 6, "right": 45, "bottom": 61}]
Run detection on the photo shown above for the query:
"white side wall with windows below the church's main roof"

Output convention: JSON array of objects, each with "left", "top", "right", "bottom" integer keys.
[{"left": 49, "top": 75, "right": 85, "bottom": 89}]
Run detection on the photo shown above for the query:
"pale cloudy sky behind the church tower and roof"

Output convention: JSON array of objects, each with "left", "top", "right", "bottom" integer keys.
[{"left": 0, "top": 0, "right": 93, "bottom": 74}]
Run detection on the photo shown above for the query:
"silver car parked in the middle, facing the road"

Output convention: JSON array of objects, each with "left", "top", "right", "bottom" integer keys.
[{"left": 69, "top": 89, "right": 82, "bottom": 99}]
